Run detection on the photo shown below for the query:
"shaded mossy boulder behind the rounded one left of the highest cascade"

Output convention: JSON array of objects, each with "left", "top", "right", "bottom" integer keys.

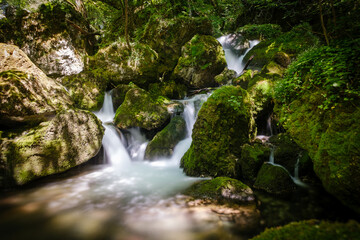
[{"left": 141, "top": 16, "right": 212, "bottom": 74}]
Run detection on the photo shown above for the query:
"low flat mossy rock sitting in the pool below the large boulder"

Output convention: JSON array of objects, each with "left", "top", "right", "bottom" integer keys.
[{"left": 184, "top": 177, "right": 255, "bottom": 202}]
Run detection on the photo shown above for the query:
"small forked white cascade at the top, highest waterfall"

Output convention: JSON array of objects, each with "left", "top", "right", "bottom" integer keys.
[{"left": 218, "top": 34, "right": 260, "bottom": 75}]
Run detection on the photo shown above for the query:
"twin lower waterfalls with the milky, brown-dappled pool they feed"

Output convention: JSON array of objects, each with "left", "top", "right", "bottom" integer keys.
[{"left": 0, "top": 93, "right": 239, "bottom": 239}]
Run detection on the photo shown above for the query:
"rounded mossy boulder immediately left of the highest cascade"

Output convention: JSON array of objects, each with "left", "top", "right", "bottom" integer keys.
[{"left": 173, "top": 35, "right": 226, "bottom": 88}]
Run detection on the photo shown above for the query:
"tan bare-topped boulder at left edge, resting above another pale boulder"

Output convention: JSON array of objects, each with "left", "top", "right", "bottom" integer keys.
[{"left": 0, "top": 43, "right": 72, "bottom": 125}]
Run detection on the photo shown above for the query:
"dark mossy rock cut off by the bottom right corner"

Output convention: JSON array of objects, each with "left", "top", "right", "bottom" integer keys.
[{"left": 252, "top": 220, "right": 360, "bottom": 240}]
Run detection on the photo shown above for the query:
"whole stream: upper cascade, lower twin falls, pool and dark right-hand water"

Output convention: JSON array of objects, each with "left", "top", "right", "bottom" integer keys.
[{"left": 0, "top": 37, "right": 354, "bottom": 240}]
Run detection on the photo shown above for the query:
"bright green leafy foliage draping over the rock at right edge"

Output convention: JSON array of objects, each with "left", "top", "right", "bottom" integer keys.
[{"left": 276, "top": 40, "right": 360, "bottom": 110}]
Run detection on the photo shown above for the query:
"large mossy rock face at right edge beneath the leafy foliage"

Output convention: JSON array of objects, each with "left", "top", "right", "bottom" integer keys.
[{"left": 276, "top": 91, "right": 360, "bottom": 213}]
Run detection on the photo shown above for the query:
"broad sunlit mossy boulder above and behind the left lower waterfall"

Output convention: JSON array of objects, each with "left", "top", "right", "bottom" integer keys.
[{"left": 86, "top": 40, "right": 161, "bottom": 87}]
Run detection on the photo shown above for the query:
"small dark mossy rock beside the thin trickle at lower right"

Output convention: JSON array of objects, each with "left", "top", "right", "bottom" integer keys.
[{"left": 254, "top": 163, "right": 296, "bottom": 195}]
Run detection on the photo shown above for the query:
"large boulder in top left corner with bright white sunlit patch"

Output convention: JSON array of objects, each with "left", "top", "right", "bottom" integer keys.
[{"left": 0, "top": 1, "right": 96, "bottom": 76}]
